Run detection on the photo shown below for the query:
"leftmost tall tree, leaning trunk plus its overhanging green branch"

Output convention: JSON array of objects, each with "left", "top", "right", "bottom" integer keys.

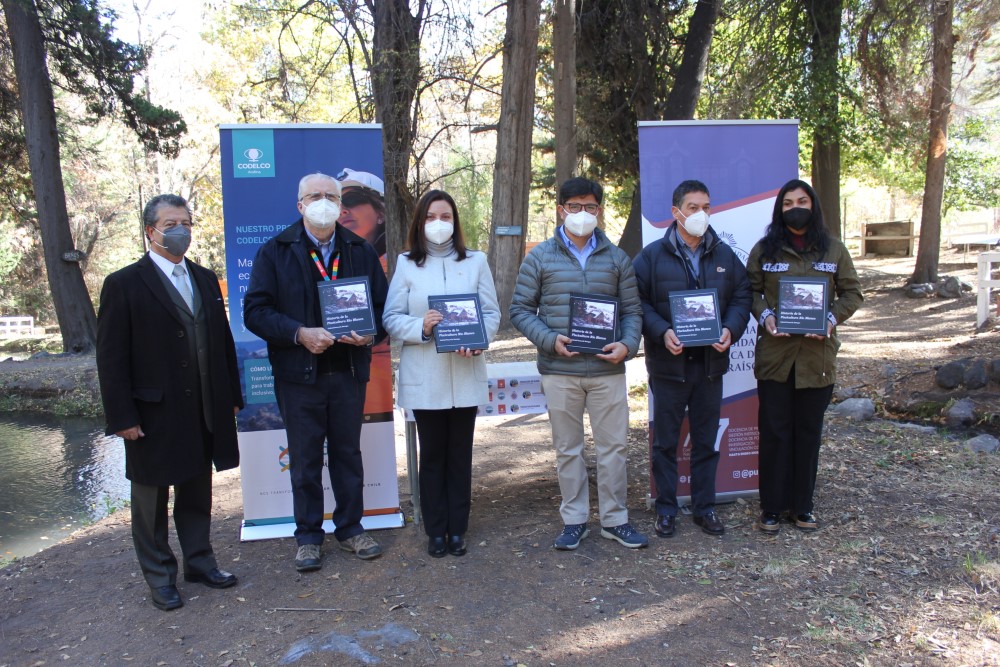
[{"left": 0, "top": 0, "right": 185, "bottom": 352}]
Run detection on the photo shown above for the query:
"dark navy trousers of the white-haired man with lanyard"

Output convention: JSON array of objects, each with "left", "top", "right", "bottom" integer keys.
[{"left": 274, "top": 371, "right": 367, "bottom": 546}]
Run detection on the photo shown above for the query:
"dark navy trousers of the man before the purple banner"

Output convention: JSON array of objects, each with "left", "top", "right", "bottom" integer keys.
[{"left": 649, "top": 362, "right": 722, "bottom": 516}]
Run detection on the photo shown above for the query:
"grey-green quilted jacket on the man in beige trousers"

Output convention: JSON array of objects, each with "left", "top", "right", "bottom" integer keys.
[{"left": 510, "top": 229, "right": 642, "bottom": 377}]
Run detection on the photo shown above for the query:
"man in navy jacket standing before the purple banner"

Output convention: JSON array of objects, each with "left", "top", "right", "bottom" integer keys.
[{"left": 634, "top": 181, "right": 752, "bottom": 537}]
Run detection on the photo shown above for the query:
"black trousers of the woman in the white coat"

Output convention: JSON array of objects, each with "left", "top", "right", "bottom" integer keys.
[{"left": 413, "top": 407, "right": 476, "bottom": 537}]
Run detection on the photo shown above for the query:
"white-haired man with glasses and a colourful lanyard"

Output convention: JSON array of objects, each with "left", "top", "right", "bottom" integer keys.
[{"left": 243, "top": 173, "right": 388, "bottom": 572}]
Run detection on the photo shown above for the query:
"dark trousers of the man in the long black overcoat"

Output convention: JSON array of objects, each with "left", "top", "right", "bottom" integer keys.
[{"left": 132, "top": 464, "right": 216, "bottom": 588}]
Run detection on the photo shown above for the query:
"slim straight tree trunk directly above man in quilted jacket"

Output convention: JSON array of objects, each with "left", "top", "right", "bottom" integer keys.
[{"left": 552, "top": 0, "right": 577, "bottom": 230}]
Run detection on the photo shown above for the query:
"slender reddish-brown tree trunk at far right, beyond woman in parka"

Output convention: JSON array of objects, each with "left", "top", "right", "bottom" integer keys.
[{"left": 910, "top": 0, "right": 955, "bottom": 283}]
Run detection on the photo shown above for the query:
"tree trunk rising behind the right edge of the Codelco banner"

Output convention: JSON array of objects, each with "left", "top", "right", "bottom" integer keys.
[{"left": 368, "top": 0, "right": 425, "bottom": 274}]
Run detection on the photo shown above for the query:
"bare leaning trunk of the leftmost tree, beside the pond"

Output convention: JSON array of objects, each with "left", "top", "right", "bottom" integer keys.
[{"left": 0, "top": 0, "right": 97, "bottom": 352}]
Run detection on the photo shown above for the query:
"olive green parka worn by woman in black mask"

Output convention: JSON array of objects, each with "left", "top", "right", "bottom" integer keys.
[{"left": 747, "top": 238, "right": 864, "bottom": 389}]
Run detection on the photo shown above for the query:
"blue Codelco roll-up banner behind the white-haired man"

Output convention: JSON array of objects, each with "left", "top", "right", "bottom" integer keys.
[{"left": 219, "top": 124, "right": 403, "bottom": 540}]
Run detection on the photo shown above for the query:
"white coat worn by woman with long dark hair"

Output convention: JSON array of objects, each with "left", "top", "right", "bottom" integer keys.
[{"left": 382, "top": 250, "right": 500, "bottom": 410}]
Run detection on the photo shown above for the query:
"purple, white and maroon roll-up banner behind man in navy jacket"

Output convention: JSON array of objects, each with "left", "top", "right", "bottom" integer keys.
[{"left": 639, "top": 120, "right": 799, "bottom": 503}]
